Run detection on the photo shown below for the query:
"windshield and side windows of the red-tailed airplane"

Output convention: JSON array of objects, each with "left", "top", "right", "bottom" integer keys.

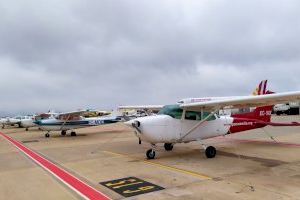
[{"left": 158, "top": 104, "right": 216, "bottom": 121}]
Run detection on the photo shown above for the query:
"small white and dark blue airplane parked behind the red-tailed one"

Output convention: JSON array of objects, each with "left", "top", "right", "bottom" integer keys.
[{"left": 34, "top": 110, "right": 121, "bottom": 137}]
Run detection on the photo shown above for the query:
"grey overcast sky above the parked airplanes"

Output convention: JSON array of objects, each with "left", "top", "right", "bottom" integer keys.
[{"left": 0, "top": 0, "right": 300, "bottom": 116}]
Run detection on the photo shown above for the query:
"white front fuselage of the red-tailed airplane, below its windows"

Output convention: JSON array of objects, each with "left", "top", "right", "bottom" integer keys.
[{"left": 129, "top": 115, "right": 233, "bottom": 144}]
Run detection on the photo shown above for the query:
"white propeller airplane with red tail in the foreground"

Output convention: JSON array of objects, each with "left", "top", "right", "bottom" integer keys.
[{"left": 125, "top": 85, "right": 300, "bottom": 159}]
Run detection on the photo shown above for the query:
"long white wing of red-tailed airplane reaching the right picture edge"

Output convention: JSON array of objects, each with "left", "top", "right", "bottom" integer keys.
[{"left": 180, "top": 91, "right": 300, "bottom": 111}]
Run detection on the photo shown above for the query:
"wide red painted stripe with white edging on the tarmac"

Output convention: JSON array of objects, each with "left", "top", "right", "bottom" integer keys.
[{"left": 0, "top": 132, "right": 110, "bottom": 200}]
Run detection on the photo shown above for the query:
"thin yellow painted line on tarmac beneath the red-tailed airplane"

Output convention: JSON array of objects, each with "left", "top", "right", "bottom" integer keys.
[{"left": 103, "top": 151, "right": 212, "bottom": 180}]
